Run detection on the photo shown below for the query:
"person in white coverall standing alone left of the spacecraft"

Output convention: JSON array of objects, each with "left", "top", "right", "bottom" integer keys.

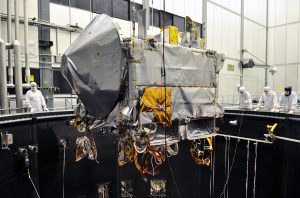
[{"left": 26, "top": 82, "right": 49, "bottom": 112}]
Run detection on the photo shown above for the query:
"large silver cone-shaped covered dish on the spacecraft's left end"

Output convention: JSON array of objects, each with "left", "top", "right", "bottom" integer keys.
[{"left": 61, "top": 14, "right": 122, "bottom": 119}]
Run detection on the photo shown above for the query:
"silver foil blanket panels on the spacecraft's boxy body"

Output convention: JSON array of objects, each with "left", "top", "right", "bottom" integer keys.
[{"left": 129, "top": 38, "right": 224, "bottom": 121}]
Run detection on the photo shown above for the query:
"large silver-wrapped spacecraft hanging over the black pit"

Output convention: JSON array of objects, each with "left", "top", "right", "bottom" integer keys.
[{"left": 61, "top": 14, "right": 224, "bottom": 174}]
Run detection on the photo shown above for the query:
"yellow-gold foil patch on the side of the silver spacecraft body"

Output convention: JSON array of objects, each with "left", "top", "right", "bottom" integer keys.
[{"left": 140, "top": 87, "right": 172, "bottom": 127}]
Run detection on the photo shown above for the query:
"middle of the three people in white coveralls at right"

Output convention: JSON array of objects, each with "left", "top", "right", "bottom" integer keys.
[{"left": 255, "top": 86, "right": 278, "bottom": 112}]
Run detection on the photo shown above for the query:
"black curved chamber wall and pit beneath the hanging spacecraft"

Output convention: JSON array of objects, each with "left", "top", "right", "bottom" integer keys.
[{"left": 0, "top": 110, "right": 300, "bottom": 198}]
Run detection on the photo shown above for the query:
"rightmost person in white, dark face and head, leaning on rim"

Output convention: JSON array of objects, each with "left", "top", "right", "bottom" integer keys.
[{"left": 278, "top": 86, "right": 298, "bottom": 114}]
